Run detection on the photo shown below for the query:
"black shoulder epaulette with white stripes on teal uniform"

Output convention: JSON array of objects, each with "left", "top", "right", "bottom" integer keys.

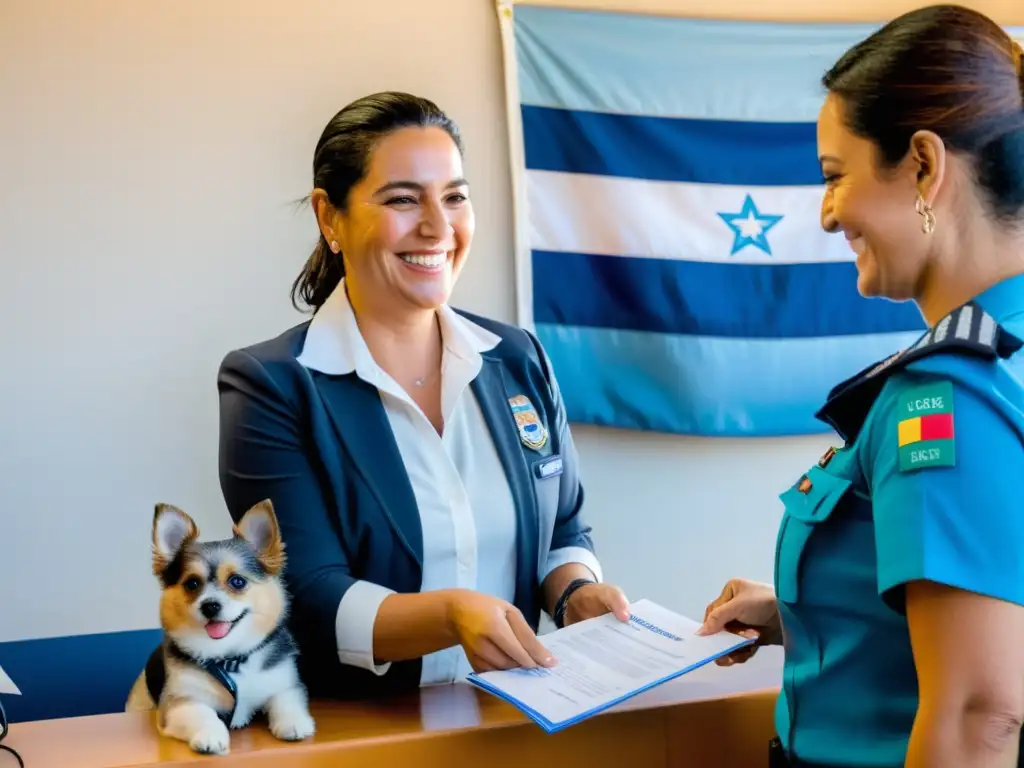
[{"left": 815, "top": 302, "right": 1024, "bottom": 442}]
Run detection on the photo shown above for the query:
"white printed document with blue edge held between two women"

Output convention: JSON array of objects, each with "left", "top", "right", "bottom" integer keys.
[{"left": 468, "top": 600, "right": 754, "bottom": 732}]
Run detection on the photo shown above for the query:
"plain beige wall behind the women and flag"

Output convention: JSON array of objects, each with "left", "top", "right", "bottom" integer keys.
[{"left": 0, "top": 0, "right": 1024, "bottom": 641}]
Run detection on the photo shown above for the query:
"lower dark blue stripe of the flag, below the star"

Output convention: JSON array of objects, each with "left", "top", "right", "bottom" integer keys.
[{"left": 534, "top": 251, "right": 925, "bottom": 337}]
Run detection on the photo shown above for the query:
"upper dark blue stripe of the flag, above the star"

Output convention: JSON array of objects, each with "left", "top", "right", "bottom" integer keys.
[{"left": 522, "top": 106, "right": 821, "bottom": 186}]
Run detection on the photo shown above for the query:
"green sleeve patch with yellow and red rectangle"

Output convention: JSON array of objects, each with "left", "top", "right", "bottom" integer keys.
[{"left": 896, "top": 381, "right": 956, "bottom": 472}]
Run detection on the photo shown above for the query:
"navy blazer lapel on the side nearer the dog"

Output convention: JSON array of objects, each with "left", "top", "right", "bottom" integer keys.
[{"left": 313, "top": 374, "right": 423, "bottom": 567}]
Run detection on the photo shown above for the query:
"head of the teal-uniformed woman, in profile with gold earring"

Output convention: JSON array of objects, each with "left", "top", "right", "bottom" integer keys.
[{"left": 818, "top": 8, "right": 1024, "bottom": 313}]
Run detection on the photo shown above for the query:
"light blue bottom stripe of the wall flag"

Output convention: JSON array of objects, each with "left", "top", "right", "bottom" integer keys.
[{"left": 537, "top": 324, "right": 919, "bottom": 437}]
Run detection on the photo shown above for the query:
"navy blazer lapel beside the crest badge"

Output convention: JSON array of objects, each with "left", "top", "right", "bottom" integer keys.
[{"left": 471, "top": 356, "right": 540, "bottom": 621}]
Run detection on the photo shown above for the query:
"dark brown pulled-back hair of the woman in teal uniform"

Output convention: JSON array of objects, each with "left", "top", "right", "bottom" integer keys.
[{"left": 822, "top": 5, "right": 1024, "bottom": 222}]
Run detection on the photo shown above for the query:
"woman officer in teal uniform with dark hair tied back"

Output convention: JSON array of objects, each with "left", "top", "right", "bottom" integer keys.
[{"left": 701, "top": 6, "right": 1024, "bottom": 768}]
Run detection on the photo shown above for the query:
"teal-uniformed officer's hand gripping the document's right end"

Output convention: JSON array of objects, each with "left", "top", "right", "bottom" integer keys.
[{"left": 697, "top": 579, "right": 782, "bottom": 667}]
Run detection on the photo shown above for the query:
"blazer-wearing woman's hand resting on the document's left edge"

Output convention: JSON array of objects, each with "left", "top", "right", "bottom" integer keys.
[{"left": 447, "top": 590, "right": 556, "bottom": 672}]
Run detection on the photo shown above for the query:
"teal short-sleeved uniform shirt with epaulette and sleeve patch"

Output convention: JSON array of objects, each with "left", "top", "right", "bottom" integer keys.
[{"left": 774, "top": 276, "right": 1024, "bottom": 766}]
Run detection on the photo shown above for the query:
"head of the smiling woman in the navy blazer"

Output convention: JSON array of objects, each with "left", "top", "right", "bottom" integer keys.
[{"left": 292, "top": 94, "right": 474, "bottom": 325}]
